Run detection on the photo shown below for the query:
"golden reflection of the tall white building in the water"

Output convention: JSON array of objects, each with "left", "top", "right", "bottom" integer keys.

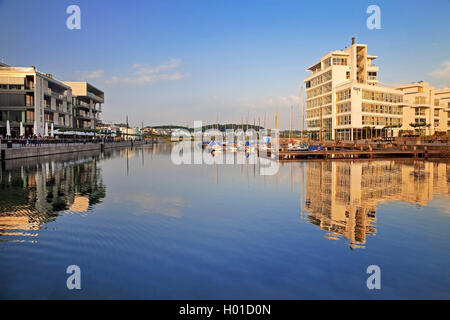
[{"left": 305, "top": 161, "right": 450, "bottom": 249}]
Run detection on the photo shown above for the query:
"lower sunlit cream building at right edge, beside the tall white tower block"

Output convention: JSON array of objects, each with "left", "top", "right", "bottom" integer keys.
[{"left": 396, "top": 81, "right": 450, "bottom": 135}]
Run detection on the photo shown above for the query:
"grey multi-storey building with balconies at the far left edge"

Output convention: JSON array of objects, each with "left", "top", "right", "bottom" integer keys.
[{"left": 0, "top": 64, "right": 72, "bottom": 137}]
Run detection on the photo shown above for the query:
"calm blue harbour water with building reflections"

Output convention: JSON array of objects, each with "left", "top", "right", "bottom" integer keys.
[{"left": 0, "top": 144, "right": 450, "bottom": 299}]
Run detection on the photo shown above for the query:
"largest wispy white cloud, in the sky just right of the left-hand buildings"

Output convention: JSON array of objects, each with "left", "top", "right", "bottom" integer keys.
[{"left": 106, "top": 59, "right": 185, "bottom": 84}]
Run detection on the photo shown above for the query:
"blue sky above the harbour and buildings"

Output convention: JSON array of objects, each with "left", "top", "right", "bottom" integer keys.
[{"left": 0, "top": 0, "right": 450, "bottom": 128}]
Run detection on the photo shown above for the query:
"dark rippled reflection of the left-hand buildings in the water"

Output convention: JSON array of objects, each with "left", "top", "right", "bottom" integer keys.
[{"left": 0, "top": 157, "right": 105, "bottom": 240}]
